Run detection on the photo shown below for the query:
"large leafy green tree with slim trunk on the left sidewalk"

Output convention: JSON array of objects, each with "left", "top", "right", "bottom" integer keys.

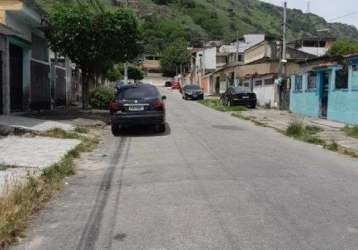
[{"left": 46, "top": 3, "right": 140, "bottom": 108}]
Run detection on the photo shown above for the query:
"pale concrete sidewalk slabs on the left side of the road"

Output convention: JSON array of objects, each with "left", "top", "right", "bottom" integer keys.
[{"left": 0, "top": 115, "right": 86, "bottom": 196}]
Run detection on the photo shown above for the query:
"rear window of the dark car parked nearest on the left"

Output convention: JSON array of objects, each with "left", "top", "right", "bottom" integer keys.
[{"left": 117, "top": 85, "right": 159, "bottom": 100}]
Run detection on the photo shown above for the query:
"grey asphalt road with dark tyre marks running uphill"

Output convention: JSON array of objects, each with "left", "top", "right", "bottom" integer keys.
[{"left": 13, "top": 87, "right": 358, "bottom": 250}]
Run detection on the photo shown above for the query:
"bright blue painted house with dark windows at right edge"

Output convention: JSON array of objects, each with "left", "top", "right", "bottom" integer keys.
[{"left": 290, "top": 54, "right": 358, "bottom": 124}]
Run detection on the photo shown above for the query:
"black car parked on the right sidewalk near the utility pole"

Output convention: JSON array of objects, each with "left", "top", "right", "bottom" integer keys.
[{"left": 220, "top": 86, "right": 257, "bottom": 108}]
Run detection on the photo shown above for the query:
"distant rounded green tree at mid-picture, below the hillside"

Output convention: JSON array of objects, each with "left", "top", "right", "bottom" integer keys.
[{"left": 160, "top": 39, "right": 190, "bottom": 76}]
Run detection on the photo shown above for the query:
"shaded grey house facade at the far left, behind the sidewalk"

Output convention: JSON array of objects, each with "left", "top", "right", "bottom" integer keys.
[{"left": 0, "top": 0, "right": 71, "bottom": 114}]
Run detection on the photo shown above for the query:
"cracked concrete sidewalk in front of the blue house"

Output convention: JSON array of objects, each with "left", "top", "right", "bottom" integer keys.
[{"left": 240, "top": 109, "right": 358, "bottom": 153}]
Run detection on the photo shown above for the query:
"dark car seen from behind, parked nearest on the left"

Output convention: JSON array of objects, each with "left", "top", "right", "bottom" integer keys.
[{"left": 110, "top": 84, "right": 166, "bottom": 136}]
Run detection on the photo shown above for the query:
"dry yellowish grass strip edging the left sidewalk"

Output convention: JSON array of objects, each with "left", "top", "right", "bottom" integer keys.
[{"left": 0, "top": 129, "right": 99, "bottom": 249}]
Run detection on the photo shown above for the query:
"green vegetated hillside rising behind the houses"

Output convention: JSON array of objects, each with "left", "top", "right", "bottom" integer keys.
[{"left": 37, "top": 0, "right": 358, "bottom": 54}]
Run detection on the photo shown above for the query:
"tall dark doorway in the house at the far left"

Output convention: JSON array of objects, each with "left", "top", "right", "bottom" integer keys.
[{"left": 10, "top": 44, "right": 23, "bottom": 112}]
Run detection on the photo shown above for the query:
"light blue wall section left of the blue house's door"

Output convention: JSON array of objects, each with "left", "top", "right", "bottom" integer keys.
[{"left": 290, "top": 73, "right": 320, "bottom": 117}]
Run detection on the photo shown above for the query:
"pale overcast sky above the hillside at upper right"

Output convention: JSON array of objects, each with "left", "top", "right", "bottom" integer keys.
[{"left": 262, "top": 0, "right": 358, "bottom": 28}]
